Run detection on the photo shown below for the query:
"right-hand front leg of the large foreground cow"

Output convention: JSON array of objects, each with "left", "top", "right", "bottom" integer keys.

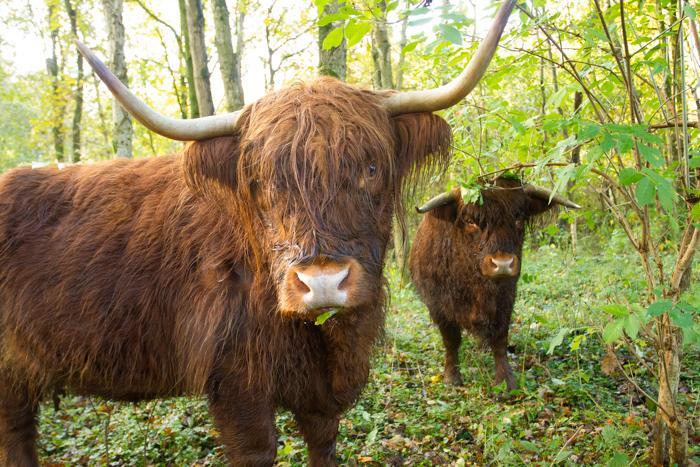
[{"left": 294, "top": 413, "right": 339, "bottom": 467}]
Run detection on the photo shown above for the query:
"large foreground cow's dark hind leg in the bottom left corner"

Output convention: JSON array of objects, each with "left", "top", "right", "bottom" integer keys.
[{"left": 0, "top": 371, "right": 39, "bottom": 467}]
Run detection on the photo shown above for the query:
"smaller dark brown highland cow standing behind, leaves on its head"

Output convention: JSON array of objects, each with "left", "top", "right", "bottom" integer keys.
[{"left": 409, "top": 178, "right": 578, "bottom": 391}]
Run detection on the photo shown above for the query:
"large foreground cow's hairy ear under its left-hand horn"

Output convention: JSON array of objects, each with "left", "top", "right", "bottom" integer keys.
[{"left": 183, "top": 136, "right": 240, "bottom": 200}]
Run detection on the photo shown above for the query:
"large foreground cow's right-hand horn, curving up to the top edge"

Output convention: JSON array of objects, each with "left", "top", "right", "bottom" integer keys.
[{"left": 384, "top": 0, "right": 516, "bottom": 115}]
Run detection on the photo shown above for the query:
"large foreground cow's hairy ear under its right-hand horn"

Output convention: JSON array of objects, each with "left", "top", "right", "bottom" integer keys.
[{"left": 393, "top": 113, "right": 452, "bottom": 183}]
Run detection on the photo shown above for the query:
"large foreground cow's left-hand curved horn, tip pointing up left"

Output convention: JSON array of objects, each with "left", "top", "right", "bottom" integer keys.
[{"left": 75, "top": 40, "right": 240, "bottom": 141}]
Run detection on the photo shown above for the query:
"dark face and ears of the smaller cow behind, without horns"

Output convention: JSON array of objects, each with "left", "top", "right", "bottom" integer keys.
[{"left": 426, "top": 178, "right": 554, "bottom": 280}]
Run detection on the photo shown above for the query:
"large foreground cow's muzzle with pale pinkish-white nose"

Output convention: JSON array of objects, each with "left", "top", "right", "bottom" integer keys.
[{"left": 280, "top": 257, "right": 367, "bottom": 314}]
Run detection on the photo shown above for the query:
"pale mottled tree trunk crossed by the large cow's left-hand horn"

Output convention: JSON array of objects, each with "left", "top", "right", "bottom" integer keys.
[{"left": 102, "top": 0, "right": 134, "bottom": 157}]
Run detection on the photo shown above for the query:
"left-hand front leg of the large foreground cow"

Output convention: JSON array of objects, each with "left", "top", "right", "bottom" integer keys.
[{"left": 209, "top": 391, "right": 277, "bottom": 467}]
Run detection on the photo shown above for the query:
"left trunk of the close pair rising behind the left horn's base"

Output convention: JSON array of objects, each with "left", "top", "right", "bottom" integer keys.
[{"left": 187, "top": 0, "right": 214, "bottom": 117}]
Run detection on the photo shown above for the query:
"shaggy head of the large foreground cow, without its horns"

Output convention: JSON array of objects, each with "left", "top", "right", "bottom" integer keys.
[{"left": 183, "top": 79, "right": 450, "bottom": 319}]
